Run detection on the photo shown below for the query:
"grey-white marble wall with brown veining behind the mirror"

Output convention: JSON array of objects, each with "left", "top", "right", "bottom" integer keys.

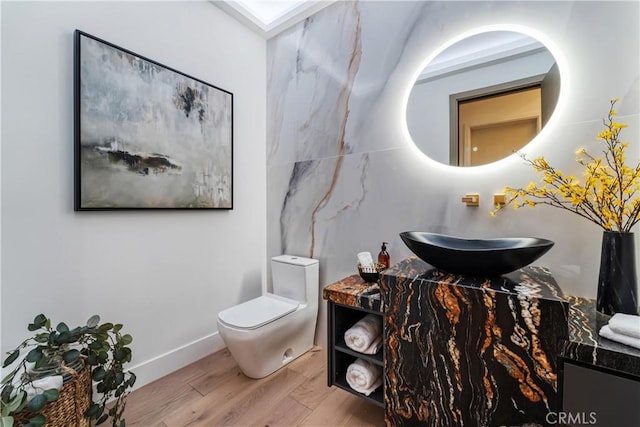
[{"left": 267, "top": 1, "right": 640, "bottom": 342}]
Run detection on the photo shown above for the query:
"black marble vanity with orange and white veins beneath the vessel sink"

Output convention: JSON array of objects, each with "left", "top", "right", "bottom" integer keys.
[{"left": 323, "top": 257, "right": 640, "bottom": 426}]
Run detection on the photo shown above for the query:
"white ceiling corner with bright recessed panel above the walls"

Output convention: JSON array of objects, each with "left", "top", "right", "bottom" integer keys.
[{"left": 211, "top": 0, "right": 335, "bottom": 39}]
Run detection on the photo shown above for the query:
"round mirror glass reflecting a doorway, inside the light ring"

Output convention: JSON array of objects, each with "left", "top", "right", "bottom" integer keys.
[{"left": 407, "top": 31, "right": 560, "bottom": 166}]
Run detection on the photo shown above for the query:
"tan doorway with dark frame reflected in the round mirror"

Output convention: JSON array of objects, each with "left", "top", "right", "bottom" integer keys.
[{"left": 458, "top": 87, "right": 541, "bottom": 166}]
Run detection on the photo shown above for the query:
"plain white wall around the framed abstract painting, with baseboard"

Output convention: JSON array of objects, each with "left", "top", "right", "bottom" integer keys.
[{"left": 1, "top": 1, "right": 266, "bottom": 386}]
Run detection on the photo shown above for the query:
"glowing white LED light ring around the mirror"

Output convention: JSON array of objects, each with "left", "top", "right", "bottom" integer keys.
[{"left": 400, "top": 24, "right": 570, "bottom": 173}]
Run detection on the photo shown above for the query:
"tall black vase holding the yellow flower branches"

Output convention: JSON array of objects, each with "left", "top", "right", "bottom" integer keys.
[{"left": 596, "top": 231, "right": 638, "bottom": 315}]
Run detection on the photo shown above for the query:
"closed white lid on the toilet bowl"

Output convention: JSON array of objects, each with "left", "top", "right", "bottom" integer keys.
[{"left": 218, "top": 295, "right": 299, "bottom": 329}]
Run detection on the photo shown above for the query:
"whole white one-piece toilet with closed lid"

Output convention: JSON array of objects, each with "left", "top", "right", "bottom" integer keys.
[{"left": 218, "top": 255, "right": 319, "bottom": 378}]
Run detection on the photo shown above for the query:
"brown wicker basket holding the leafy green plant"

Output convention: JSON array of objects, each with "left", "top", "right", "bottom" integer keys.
[{"left": 13, "top": 366, "right": 92, "bottom": 427}]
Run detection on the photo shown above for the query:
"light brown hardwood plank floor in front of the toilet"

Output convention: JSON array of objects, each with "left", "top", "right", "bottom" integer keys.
[{"left": 125, "top": 347, "right": 384, "bottom": 427}]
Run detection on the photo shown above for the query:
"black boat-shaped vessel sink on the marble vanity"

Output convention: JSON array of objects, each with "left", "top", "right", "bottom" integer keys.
[{"left": 400, "top": 231, "right": 553, "bottom": 277}]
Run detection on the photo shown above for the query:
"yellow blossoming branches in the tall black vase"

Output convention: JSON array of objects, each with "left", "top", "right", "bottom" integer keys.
[{"left": 491, "top": 99, "right": 640, "bottom": 232}]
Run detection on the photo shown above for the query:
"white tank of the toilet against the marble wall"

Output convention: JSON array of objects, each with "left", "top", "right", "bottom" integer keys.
[{"left": 271, "top": 255, "right": 319, "bottom": 305}]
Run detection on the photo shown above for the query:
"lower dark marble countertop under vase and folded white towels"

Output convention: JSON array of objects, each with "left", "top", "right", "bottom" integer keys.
[{"left": 560, "top": 296, "right": 640, "bottom": 379}]
